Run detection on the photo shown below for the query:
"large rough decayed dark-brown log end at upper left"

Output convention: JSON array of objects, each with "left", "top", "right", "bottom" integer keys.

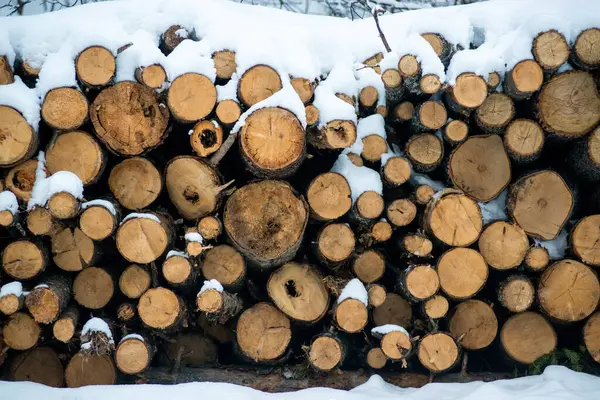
[{"left": 92, "top": 82, "right": 173, "bottom": 156}]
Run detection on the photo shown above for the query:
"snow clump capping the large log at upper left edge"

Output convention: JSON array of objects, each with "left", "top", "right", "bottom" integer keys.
[{"left": 0, "top": 76, "right": 40, "bottom": 132}]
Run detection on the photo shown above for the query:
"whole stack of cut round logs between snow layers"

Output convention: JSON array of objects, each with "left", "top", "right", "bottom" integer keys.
[{"left": 0, "top": 20, "right": 600, "bottom": 387}]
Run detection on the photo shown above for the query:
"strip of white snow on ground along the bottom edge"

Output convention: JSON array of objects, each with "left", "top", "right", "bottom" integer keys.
[{"left": 0, "top": 367, "right": 600, "bottom": 400}]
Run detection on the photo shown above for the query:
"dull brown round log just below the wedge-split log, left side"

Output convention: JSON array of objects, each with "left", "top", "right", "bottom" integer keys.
[{"left": 73, "top": 267, "right": 115, "bottom": 310}]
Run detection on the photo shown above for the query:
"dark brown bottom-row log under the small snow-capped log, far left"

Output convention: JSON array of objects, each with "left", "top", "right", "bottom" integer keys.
[{"left": 65, "top": 352, "right": 117, "bottom": 388}]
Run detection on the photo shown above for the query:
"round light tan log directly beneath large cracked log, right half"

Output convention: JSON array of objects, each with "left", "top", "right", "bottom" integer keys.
[{"left": 437, "top": 248, "right": 489, "bottom": 300}]
